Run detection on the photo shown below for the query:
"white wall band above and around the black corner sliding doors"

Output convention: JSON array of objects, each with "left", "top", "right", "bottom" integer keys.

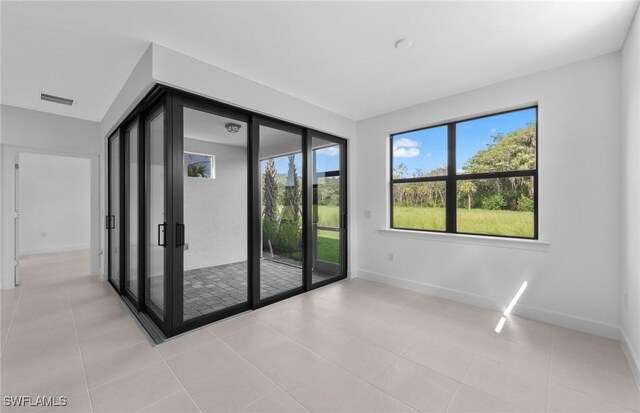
[{"left": 101, "top": 44, "right": 357, "bottom": 273}]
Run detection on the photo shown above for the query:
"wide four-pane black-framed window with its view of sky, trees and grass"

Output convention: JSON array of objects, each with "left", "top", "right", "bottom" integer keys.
[{"left": 390, "top": 106, "right": 538, "bottom": 239}]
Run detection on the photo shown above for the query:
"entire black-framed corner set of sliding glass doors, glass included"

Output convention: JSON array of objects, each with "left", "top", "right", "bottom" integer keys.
[{"left": 106, "top": 86, "right": 347, "bottom": 339}]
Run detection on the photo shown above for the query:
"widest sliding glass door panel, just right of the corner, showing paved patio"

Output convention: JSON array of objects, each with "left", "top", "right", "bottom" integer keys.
[{"left": 173, "top": 97, "right": 250, "bottom": 329}]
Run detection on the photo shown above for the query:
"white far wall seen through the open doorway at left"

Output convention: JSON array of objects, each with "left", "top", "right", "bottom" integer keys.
[{"left": 18, "top": 153, "right": 91, "bottom": 256}]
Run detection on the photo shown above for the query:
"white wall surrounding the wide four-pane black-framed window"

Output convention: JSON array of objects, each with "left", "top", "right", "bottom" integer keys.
[{"left": 352, "top": 53, "right": 621, "bottom": 337}]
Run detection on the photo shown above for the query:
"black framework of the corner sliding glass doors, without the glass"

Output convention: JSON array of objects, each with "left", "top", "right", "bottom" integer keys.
[{"left": 106, "top": 85, "right": 348, "bottom": 337}]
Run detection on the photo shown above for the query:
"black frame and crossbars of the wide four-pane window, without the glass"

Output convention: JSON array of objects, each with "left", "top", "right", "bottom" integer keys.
[{"left": 388, "top": 104, "right": 540, "bottom": 240}]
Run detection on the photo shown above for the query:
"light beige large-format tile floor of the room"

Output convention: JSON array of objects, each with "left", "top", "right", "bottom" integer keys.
[{"left": 0, "top": 253, "right": 640, "bottom": 413}]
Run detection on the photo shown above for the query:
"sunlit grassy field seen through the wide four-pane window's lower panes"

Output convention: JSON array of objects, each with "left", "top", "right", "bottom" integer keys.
[{"left": 393, "top": 207, "right": 533, "bottom": 237}]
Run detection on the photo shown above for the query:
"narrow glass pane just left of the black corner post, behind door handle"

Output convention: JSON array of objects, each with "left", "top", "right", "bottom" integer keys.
[{"left": 145, "top": 111, "right": 167, "bottom": 319}]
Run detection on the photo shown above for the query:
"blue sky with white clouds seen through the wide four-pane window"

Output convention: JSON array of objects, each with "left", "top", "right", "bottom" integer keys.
[{"left": 393, "top": 108, "right": 536, "bottom": 177}]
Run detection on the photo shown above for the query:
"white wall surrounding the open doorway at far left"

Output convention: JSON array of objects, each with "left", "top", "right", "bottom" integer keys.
[{"left": 0, "top": 105, "right": 104, "bottom": 289}]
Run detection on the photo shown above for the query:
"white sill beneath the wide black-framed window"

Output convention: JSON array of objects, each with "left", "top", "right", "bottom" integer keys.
[{"left": 378, "top": 229, "right": 551, "bottom": 252}]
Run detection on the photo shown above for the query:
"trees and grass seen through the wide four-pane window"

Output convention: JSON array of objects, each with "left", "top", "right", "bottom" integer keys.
[{"left": 393, "top": 123, "right": 536, "bottom": 237}]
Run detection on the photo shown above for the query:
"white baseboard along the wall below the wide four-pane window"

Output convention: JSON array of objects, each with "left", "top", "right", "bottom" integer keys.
[{"left": 358, "top": 270, "right": 621, "bottom": 340}]
